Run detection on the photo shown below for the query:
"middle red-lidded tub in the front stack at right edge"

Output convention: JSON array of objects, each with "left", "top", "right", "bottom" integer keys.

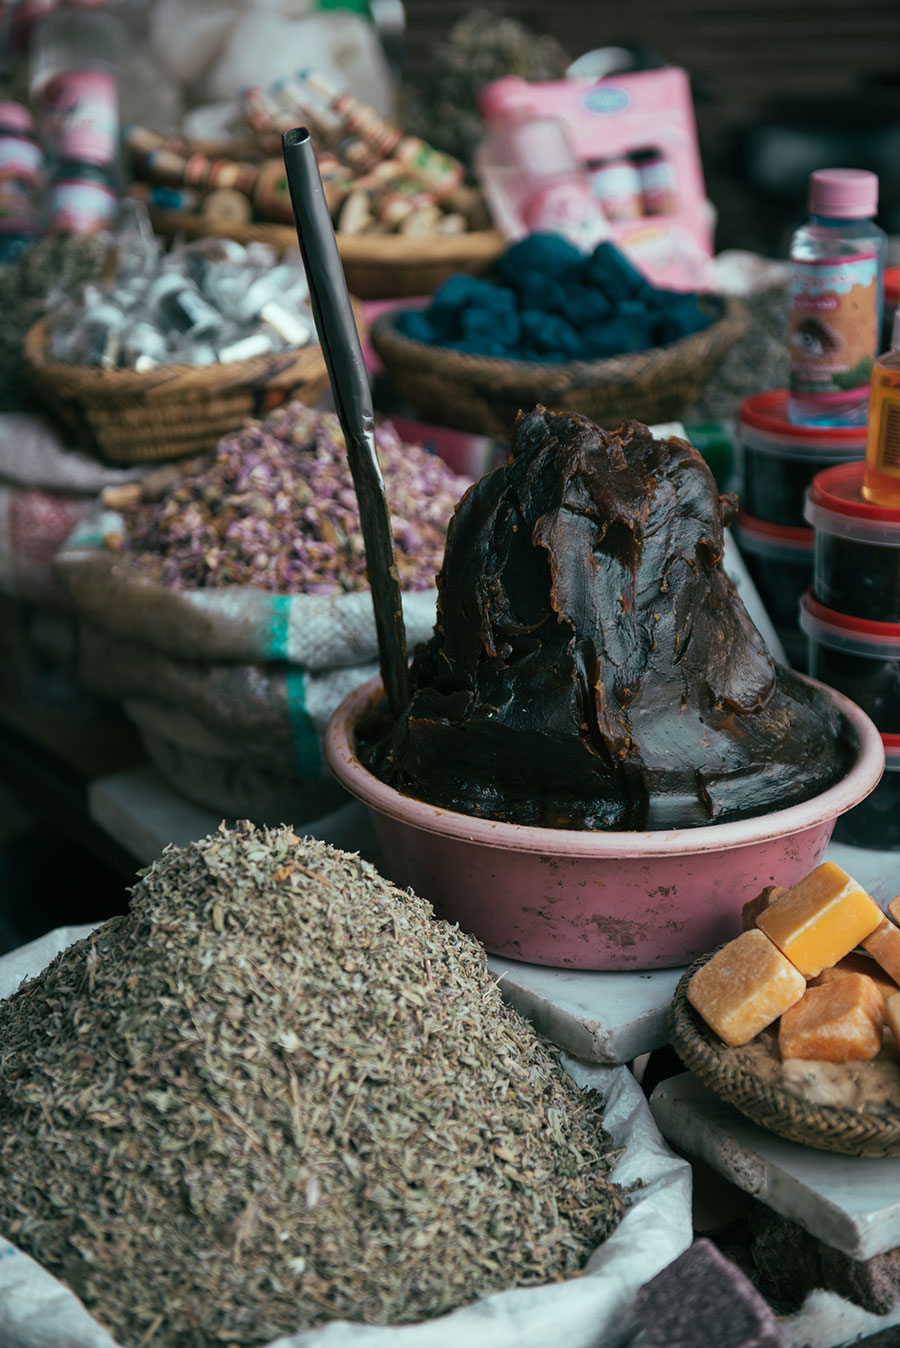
[{"left": 800, "top": 594, "right": 900, "bottom": 735}]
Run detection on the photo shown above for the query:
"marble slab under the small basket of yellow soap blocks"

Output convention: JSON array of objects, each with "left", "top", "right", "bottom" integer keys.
[{"left": 649, "top": 1072, "right": 900, "bottom": 1259}]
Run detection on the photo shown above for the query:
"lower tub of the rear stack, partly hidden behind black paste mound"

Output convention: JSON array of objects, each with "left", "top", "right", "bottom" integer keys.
[{"left": 734, "top": 511, "right": 812, "bottom": 669}]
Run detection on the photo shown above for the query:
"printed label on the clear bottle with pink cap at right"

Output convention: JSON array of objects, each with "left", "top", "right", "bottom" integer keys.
[{"left": 790, "top": 253, "right": 878, "bottom": 407}]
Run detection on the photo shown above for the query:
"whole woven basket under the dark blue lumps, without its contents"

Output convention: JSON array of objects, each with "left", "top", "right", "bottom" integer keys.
[{"left": 371, "top": 295, "right": 748, "bottom": 439}]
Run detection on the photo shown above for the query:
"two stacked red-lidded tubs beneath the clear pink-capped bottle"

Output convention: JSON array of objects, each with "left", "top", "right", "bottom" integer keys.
[{"left": 736, "top": 388, "right": 866, "bottom": 669}]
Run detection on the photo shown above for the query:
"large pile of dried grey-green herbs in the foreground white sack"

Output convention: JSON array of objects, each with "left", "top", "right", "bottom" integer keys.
[{"left": 0, "top": 822, "right": 622, "bottom": 1348}]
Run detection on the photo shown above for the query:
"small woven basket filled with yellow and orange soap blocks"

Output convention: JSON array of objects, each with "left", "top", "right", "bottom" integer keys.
[{"left": 668, "top": 863, "right": 900, "bottom": 1157}]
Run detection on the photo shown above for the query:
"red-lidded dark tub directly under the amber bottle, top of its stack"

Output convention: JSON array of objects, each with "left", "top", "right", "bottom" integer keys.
[{"left": 804, "top": 464, "right": 900, "bottom": 623}]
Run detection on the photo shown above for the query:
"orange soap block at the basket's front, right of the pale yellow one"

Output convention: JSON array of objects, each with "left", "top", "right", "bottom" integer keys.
[{"left": 779, "top": 973, "right": 884, "bottom": 1062}]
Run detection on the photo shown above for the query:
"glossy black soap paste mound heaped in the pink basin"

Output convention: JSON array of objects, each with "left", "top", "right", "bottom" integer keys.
[{"left": 361, "top": 407, "right": 856, "bottom": 829}]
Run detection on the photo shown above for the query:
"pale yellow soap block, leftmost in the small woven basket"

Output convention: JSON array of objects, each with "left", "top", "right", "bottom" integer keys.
[{"left": 687, "top": 930, "right": 806, "bottom": 1049}]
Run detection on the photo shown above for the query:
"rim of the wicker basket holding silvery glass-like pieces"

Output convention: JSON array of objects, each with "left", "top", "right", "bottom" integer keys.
[{"left": 23, "top": 314, "right": 328, "bottom": 403}]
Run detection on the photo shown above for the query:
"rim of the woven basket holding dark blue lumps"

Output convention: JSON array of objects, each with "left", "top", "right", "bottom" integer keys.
[{"left": 371, "top": 295, "right": 748, "bottom": 395}]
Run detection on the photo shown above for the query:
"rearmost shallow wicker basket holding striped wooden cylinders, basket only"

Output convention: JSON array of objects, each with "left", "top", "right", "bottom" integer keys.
[{"left": 138, "top": 194, "right": 507, "bottom": 299}]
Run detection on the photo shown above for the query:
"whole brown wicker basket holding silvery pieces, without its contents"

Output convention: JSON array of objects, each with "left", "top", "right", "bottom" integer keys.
[{"left": 23, "top": 313, "right": 340, "bottom": 464}]
